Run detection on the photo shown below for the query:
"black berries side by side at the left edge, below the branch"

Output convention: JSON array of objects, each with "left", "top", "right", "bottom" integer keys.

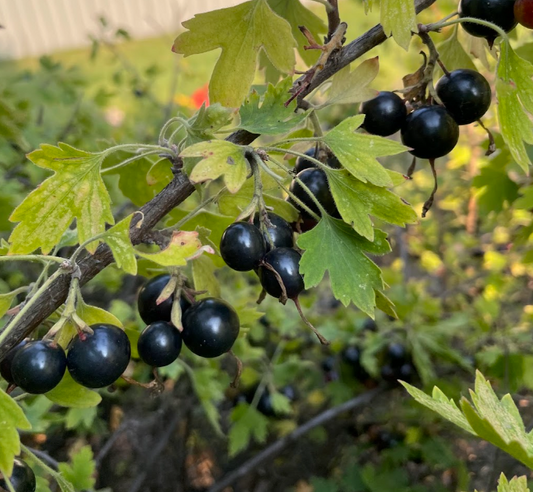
[{"left": 0, "top": 323, "right": 131, "bottom": 394}]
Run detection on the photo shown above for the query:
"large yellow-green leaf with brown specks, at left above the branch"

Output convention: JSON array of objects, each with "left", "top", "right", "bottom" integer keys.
[{"left": 9, "top": 143, "right": 114, "bottom": 254}]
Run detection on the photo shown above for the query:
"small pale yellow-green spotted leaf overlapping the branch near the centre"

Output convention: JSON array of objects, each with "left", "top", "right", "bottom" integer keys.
[{"left": 180, "top": 140, "right": 248, "bottom": 193}]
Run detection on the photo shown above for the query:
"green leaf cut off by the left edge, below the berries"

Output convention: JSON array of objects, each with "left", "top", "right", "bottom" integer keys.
[{"left": 0, "top": 389, "right": 31, "bottom": 477}]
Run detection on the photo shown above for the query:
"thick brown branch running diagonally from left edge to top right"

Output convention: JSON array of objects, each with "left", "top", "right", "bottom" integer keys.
[{"left": 0, "top": 0, "right": 436, "bottom": 360}]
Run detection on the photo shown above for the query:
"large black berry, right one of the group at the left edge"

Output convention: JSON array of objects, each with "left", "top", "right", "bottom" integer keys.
[{"left": 67, "top": 323, "right": 131, "bottom": 388}]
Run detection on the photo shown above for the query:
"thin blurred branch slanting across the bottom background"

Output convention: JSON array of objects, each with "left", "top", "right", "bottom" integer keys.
[{"left": 209, "top": 388, "right": 383, "bottom": 492}]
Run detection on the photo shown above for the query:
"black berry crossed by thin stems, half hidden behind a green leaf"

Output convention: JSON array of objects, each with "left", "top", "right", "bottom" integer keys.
[{"left": 290, "top": 168, "right": 340, "bottom": 218}]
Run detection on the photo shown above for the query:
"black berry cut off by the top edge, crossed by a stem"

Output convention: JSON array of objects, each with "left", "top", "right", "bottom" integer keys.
[{"left": 459, "top": 0, "right": 517, "bottom": 43}]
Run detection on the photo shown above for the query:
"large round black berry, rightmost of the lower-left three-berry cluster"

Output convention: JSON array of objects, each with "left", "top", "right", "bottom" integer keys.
[{"left": 181, "top": 296, "right": 241, "bottom": 358}]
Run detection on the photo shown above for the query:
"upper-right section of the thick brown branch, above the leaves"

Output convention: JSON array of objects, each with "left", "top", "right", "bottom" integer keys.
[{"left": 298, "top": 0, "right": 437, "bottom": 102}]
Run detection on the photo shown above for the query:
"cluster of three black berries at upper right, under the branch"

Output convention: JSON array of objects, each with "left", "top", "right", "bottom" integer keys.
[{"left": 361, "top": 69, "right": 492, "bottom": 159}]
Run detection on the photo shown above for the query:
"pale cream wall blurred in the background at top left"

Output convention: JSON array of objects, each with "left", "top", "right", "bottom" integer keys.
[{"left": 0, "top": 0, "right": 243, "bottom": 58}]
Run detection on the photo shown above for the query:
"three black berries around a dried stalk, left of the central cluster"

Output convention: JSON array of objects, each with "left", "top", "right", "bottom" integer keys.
[{"left": 137, "top": 274, "right": 240, "bottom": 367}]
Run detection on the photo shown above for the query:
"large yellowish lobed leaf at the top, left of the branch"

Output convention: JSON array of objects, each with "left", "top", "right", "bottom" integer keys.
[{"left": 172, "top": 0, "right": 296, "bottom": 108}]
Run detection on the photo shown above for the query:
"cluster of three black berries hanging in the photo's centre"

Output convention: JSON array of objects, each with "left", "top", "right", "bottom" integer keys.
[{"left": 220, "top": 212, "right": 304, "bottom": 299}]
